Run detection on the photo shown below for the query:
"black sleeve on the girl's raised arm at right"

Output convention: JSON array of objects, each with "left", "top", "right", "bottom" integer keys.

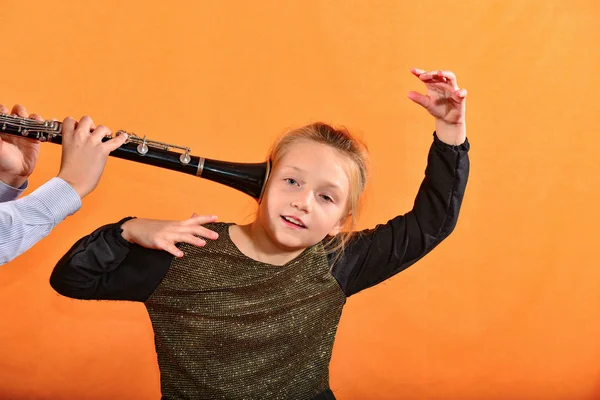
[{"left": 329, "top": 133, "right": 470, "bottom": 296}]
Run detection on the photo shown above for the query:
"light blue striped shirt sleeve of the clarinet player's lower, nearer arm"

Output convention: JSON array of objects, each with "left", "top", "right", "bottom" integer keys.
[{"left": 0, "top": 178, "right": 81, "bottom": 265}]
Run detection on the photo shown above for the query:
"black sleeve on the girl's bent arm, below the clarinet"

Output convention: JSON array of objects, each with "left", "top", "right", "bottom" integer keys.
[{"left": 50, "top": 218, "right": 173, "bottom": 301}]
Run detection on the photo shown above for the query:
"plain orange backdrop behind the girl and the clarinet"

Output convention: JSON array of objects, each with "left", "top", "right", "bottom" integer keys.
[{"left": 0, "top": 0, "right": 600, "bottom": 400}]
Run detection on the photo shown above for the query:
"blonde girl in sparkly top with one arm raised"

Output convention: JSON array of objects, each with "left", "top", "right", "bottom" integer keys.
[{"left": 50, "top": 69, "right": 469, "bottom": 400}]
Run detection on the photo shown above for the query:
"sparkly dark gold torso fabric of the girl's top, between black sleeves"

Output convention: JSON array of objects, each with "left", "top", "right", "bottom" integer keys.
[{"left": 146, "top": 223, "right": 346, "bottom": 400}]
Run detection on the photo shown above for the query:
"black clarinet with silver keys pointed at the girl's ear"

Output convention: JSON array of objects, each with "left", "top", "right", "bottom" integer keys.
[{"left": 0, "top": 114, "right": 271, "bottom": 200}]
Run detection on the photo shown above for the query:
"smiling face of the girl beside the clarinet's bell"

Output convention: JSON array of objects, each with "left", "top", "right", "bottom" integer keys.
[{"left": 256, "top": 140, "right": 350, "bottom": 251}]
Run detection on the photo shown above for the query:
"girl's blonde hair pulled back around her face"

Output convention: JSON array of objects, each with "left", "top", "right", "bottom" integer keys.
[{"left": 268, "top": 122, "right": 369, "bottom": 259}]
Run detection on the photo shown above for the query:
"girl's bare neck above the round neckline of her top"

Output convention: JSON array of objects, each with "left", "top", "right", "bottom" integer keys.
[{"left": 229, "top": 221, "right": 304, "bottom": 266}]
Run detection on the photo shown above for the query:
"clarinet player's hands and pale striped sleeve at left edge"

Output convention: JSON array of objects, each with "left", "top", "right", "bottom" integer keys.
[{"left": 0, "top": 105, "right": 127, "bottom": 265}]
